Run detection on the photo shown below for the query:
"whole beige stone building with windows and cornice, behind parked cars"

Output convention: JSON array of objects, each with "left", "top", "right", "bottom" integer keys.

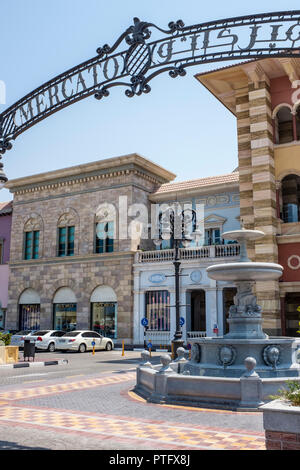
[{"left": 6, "top": 154, "right": 175, "bottom": 342}]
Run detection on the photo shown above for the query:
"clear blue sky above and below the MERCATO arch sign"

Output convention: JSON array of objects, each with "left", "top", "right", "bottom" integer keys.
[{"left": 0, "top": 0, "right": 299, "bottom": 201}]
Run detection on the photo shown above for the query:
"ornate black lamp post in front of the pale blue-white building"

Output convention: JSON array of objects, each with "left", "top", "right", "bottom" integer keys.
[{"left": 154, "top": 207, "right": 202, "bottom": 357}]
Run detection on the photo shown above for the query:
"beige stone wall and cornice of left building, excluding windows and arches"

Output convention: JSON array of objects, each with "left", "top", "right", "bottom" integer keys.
[{"left": 6, "top": 154, "right": 175, "bottom": 342}]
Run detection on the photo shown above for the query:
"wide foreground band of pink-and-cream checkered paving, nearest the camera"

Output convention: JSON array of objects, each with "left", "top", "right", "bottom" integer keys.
[{"left": 0, "top": 405, "right": 265, "bottom": 450}]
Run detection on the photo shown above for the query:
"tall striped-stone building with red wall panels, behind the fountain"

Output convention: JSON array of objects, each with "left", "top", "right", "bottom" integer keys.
[{"left": 196, "top": 58, "right": 300, "bottom": 336}]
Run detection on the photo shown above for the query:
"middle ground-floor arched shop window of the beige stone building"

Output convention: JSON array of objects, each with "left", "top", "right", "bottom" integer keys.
[{"left": 53, "top": 287, "right": 77, "bottom": 331}]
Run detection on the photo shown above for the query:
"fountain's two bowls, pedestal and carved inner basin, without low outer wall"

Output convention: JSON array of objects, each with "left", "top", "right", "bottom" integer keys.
[{"left": 186, "top": 229, "right": 300, "bottom": 378}]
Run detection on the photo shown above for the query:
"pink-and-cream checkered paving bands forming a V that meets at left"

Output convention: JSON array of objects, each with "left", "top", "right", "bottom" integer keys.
[{"left": 0, "top": 372, "right": 265, "bottom": 450}]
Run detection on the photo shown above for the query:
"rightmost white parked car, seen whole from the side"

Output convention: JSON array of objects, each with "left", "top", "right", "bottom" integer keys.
[{"left": 56, "top": 330, "right": 114, "bottom": 353}]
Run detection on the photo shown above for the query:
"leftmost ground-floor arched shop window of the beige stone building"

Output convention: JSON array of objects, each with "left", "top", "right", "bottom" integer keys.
[{"left": 19, "top": 288, "right": 41, "bottom": 331}]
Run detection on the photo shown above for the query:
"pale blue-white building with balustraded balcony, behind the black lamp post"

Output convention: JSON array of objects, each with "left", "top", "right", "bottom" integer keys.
[{"left": 134, "top": 172, "right": 240, "bottom": 345}]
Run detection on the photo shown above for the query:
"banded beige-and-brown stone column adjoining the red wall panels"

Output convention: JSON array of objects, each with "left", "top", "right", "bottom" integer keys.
[{"left": 249, "top": 64, "right": 280, "bottom": 335}]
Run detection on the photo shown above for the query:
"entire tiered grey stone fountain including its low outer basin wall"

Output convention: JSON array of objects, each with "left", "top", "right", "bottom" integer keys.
[{"left": 136, "top": 228, "right": 300, "bottom": 410}]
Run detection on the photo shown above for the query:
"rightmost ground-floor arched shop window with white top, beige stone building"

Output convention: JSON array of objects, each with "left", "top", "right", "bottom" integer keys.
[{"left": 90, "top": 286, "right": 118, "bottom": 338}]
